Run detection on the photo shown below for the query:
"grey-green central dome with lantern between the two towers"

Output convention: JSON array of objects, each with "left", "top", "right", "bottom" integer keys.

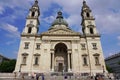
[{"left": 52, "top": 11, "right": 68, "bottom": 26}]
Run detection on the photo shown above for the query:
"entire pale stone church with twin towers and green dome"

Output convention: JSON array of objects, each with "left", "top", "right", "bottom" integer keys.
[{"left": 15, "top": 0, "right": 106, "bottom": 74}]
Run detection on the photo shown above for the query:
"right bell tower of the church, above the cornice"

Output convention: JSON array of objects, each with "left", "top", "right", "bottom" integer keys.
[{"left": 81, "top": 0, "right": 98, "bottom": 35}]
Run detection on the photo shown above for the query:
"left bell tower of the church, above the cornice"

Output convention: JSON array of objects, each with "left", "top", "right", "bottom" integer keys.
[{"left": 22, "top": 0, "right": 40, "bottom": 35}]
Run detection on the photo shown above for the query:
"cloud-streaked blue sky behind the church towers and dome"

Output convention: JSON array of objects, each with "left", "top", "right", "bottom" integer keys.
[{"left": 0, "top": 0, "right": 120, "bottom": 58}]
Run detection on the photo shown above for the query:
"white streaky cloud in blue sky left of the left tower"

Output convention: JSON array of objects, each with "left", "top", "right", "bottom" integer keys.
[{"left": 0, "top": 24, "right": 20, "bottom": 38}]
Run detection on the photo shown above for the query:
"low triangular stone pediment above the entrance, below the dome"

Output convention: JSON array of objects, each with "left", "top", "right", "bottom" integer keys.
[{"left": 42, "top": 29, "right": 80, "bottom": 35}]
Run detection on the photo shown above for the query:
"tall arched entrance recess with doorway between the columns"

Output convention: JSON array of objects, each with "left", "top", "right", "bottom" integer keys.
[{"left": 55, "top": 43, "right": 68, "bottom": 72}]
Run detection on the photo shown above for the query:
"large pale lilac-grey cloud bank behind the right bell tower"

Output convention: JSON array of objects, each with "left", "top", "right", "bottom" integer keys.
[{"left": 39, "top": 0, "right": 120, "bottom": 34}]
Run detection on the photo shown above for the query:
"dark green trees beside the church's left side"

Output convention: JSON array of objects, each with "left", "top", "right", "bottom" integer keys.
[{"left": 0, "top": 60, "right": 16, "bottom": 72}]
